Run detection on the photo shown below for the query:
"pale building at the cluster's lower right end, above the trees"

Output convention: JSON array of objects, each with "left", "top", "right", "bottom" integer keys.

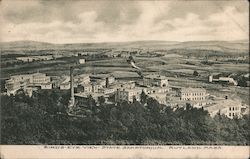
[{"left": 203, "top": 99, "right": 243, "bottom": 119}]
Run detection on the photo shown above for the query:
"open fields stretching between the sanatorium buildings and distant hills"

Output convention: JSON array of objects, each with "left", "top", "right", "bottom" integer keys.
[{"left": 1, "top": 42, "right": 249, "bottom": 103}]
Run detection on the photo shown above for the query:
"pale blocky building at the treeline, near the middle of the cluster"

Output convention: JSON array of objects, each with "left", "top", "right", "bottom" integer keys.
[{"left": 115, "top": 88, "right": 142, "bottom": 102}]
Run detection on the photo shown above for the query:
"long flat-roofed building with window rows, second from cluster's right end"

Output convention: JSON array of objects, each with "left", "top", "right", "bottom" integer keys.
[{"left": 177, "top": 88, "right": 207, "bottom": 101}]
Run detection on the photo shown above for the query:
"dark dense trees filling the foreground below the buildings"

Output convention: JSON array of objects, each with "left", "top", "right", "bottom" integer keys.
[{"left": 1, "top": 90, "right": 250, "bottom": 145}]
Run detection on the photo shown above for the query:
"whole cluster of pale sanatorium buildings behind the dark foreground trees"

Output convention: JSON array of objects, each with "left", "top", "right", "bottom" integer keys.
[{"left": 5, "top": 72, "right": 246, "bottom": 118}]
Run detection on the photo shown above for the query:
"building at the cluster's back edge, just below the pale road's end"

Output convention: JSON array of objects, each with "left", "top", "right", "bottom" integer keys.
[{"left": 143, "top": 74, "right": 168, "bottom": 87}]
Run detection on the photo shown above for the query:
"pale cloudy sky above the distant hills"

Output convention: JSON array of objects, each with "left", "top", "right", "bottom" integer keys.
[{"left": 0, "top": 0, "right": 249, "bottom": 43}]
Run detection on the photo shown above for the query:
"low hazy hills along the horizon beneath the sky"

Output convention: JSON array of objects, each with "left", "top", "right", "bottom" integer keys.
[{"left": 0, "top": 40, "right": 249, "bottom": 52}]
